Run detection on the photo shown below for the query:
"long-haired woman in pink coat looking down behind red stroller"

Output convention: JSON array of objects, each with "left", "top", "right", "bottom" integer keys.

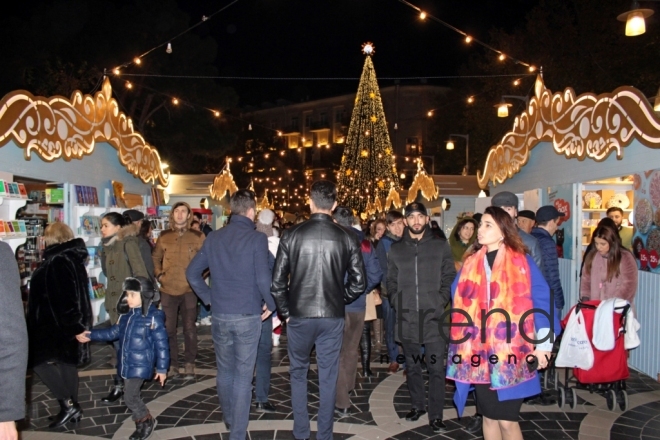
[{"left": 580, "top": 222, "right": 637, "bottom": 304}]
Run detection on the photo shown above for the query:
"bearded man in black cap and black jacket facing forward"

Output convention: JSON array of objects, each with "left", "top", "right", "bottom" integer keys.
[{"left": 387, "top": 203, "right": 456, "bottom": 432}]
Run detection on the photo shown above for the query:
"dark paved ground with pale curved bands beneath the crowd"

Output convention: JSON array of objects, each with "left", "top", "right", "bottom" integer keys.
[{"left": 19, "top": 327, "right": 660, "bottom": 440}]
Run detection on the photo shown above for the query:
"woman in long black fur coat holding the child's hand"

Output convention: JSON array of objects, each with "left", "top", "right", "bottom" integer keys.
[{"left": 27, "top": 222, "right": 92, "bottom": 428}]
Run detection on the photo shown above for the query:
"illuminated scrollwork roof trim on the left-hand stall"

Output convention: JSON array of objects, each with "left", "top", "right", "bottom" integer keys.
[{"left": 0, "top": 78, "right": 169, "bottom": 186}]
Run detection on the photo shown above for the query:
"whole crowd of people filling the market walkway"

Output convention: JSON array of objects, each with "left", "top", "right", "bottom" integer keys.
[{"left": 0, "top": 181, "right": 637, "bottom": 440}]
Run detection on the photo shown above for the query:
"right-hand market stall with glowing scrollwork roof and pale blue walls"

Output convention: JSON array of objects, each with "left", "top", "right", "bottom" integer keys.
[{"left": 477, "top": 75, "right": 660, "bottom": 377}]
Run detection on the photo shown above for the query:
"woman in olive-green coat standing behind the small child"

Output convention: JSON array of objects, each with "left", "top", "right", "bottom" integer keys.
[{"left": 99, "top": 212, "right": 149, "bottom": 404}]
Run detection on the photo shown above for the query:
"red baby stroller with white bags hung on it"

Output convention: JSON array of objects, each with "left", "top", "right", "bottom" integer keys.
[{"left": 557, "top": 300, "right": 630, "bottom": 411}]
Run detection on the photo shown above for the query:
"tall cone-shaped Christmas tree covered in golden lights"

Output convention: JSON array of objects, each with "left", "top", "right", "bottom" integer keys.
[{"left": 337, "top": 43, "right": 399, "bottom": 213}]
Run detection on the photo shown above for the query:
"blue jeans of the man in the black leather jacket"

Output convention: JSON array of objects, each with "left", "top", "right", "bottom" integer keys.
[{"left": 286, "top": 318, "right": 344, "bottom": 440}]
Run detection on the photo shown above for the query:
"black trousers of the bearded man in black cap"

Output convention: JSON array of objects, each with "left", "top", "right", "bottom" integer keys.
[{"left": 402, "top": 338, "right": 446, "bottom": 420}]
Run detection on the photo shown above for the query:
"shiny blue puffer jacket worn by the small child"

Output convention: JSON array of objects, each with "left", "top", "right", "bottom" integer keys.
[{"left": 89, "top": 305, "right": 170, "bottom": 380}]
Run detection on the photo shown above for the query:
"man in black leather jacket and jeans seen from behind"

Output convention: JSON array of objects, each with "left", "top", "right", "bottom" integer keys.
[{"left": 271, "top": 180, "right": 367, "bottom": 440}]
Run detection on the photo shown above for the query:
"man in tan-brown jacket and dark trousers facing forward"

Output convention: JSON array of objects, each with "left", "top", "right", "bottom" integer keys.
[{"left": 152, "top": 202, "right": 204, "bottom": 379}]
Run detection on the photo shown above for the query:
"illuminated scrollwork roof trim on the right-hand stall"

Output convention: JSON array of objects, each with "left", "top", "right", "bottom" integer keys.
[{"left": 477, "top": 75, "right": 660, "bottom": 188}]
